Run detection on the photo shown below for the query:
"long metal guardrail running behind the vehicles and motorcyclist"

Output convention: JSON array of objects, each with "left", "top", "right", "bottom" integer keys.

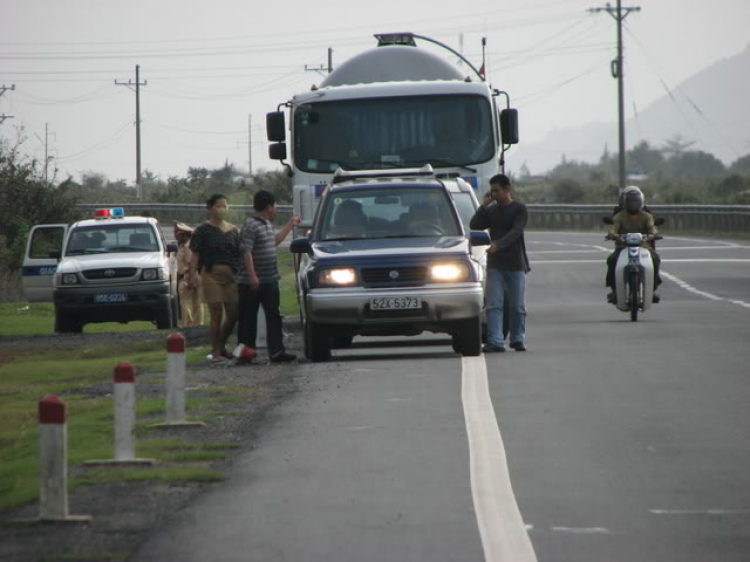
[{"left": 76, "top": 203, "right": 750, "bottom": 233}]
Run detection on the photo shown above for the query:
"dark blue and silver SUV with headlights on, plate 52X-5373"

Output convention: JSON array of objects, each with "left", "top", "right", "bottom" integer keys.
[{"left": 291, "top": 166, "right": 490, "bottom": 361}]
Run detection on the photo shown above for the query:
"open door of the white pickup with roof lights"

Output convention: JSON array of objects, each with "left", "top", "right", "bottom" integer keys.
[{"left": 21, "top": 224, "right": 68, "bottom": 302}]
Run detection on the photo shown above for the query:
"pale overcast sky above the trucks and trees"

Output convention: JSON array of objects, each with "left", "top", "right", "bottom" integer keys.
[{"left": 0, "top": 0, "right": 750, "bottom": 184}]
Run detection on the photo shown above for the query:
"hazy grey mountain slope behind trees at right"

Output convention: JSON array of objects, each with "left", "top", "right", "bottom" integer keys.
[{"left": 511, "top": 45, "right": 750, "bottom": 174}]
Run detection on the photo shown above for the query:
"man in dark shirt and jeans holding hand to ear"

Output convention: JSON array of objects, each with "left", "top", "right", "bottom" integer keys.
[{"left": 470, "top": 174, "right": 530, "bottom": 353}]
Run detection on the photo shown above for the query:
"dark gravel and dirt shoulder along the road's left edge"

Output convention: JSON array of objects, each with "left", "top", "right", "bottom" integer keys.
[{"left": 0, "top": 322, "right": 312, "bottom": 562}]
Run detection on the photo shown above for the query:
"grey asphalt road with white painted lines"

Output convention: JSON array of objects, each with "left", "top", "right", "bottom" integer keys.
[{"left": 135, "top": 233, "right": 750, "bottom": 562}]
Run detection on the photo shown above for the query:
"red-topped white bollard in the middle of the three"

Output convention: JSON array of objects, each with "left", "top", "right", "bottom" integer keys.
[{"left": 85, "top": 361, "right": 154, "bottom": 465}]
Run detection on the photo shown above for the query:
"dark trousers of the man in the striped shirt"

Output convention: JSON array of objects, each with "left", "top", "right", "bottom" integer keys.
[{"left": 237, "top": 281, "right": 284, "bottom": 357}]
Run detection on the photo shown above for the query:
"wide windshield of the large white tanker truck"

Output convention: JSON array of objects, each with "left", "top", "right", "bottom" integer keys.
[{"left": 294, "top": 95, "right": 495, "bottom": 173}]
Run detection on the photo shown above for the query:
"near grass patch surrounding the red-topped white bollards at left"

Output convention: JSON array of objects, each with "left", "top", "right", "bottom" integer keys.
[{"left": 0, "top": 341, "right": 248, "bottom": 509}]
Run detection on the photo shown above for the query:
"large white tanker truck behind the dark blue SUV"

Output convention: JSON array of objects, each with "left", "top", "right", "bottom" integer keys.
[{"left": 266, "top": 33, "right": 518, "bottom": 227}]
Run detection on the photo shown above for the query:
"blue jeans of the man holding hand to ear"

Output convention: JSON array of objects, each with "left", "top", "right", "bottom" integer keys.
[{"left": 484, "top": 267, "right": 526, "bottom": 347}]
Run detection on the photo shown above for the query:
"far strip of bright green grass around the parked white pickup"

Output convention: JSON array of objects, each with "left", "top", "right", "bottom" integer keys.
[{"left": 0, "top": 249, "right": 299, "bottom": 336}]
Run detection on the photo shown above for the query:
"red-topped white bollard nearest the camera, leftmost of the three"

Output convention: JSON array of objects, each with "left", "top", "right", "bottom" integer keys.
[{"left": 38, "top": 394, "right": 91, "bottom": 521}]
